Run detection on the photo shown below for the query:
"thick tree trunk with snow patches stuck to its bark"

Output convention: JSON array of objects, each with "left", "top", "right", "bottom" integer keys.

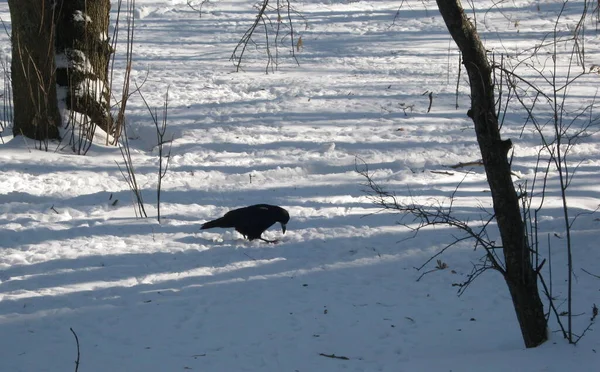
[{"left": 56, "top": 0, "right": 115, "bottom": 139}]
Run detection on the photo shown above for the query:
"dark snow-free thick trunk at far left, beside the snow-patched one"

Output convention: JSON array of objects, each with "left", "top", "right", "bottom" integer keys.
[{"left": 8, "top": 0, "right": 61, "bottom": 140}]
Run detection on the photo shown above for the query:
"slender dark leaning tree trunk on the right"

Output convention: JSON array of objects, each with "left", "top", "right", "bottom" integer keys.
[{"left": 437, "top": 0, "right": 548, "bottom": 348}]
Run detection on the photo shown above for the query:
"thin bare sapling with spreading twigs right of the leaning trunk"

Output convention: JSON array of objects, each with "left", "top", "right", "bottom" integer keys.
[{"left": 493, "top": 1, "right": 600, "bottom": 344}]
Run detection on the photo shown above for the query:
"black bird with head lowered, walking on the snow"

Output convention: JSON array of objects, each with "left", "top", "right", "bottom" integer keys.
[{"left": 200, "top": 204, "right": 290, "bottom": 243}]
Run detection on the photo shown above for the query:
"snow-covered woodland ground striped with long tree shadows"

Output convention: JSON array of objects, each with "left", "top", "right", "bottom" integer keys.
[{"left": 0, "top": 0, "right": 600, "bottom": 372}]
